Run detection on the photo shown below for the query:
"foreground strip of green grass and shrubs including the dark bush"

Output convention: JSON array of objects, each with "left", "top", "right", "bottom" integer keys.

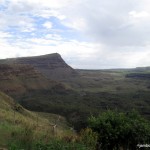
[{"left": 0, "top": 107, "right": 150, "bottom": 150}]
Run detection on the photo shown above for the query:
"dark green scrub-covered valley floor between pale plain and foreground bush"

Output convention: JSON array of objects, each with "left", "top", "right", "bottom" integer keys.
[{"left": 17, "top": 90, "right": 150, "bottom": 131}]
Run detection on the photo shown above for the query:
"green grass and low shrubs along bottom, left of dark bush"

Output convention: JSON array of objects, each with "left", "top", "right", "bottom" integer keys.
[{"left": 0, "top": 122, "right": 97, "bottom": 150}]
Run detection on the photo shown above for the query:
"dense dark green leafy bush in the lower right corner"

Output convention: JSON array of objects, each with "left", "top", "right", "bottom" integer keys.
[{"left": 89, "top": 110, "right": 150, "bottom": 150}]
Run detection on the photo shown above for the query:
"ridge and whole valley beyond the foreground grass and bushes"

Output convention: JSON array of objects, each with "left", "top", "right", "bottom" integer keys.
[{"left": 0, "top": 54, "right": 150, "bottom": 130}]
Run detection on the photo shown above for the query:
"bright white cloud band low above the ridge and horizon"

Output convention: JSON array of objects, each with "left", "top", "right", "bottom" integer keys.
[{"left": 0, "top": 32, "right": 150, "bottom": 69}]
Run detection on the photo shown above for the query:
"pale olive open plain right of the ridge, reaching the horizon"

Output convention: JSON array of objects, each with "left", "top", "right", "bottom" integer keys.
[{"left": 63, "top": 69, "right": 150, "bottom": 93}]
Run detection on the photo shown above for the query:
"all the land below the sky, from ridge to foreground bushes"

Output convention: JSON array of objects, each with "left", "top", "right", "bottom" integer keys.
[{"left": 0, "top": 54, "right": 150, "bottom": 150}]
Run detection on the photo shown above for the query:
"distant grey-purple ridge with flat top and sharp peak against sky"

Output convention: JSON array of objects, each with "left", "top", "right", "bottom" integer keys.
[{"left": 0, "top": 53, "right": 77, "bottom": 81}]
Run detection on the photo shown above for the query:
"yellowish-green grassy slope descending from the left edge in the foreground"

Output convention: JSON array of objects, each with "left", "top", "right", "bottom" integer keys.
[{"left": 0, "top": 92, "right": 70, "bottom": 147}]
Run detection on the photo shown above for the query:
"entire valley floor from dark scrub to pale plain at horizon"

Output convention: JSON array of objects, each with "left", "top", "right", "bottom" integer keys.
[{"left": 17, "top": 69, "right": 150, "bottom": 129}]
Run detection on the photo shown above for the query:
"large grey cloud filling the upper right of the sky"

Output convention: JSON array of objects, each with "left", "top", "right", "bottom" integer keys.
[{"left": 62, "top": 0, "right": 150, "bottom": 46}]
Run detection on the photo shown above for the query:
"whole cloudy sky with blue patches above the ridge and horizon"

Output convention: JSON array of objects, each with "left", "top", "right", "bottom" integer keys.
[{"left": 0, "top": 0, "right": 150, "bottom": 69}]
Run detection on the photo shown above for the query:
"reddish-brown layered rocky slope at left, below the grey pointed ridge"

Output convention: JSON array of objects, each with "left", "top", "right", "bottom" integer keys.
[{"left": 0, "top": 64, "right": 57, "bottom": 95}]
